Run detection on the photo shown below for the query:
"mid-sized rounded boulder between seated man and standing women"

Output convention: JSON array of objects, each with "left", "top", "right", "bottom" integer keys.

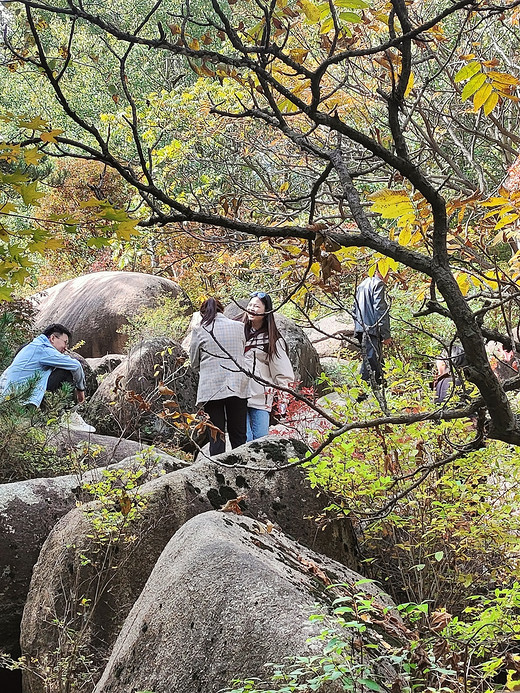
[{"left": 85, "top": 337, "right": 198, "bottom": 445}]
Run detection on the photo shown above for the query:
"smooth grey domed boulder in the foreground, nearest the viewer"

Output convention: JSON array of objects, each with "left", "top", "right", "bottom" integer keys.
[{"left": 95, "top": 512, "right": 390, "bottom": 693}]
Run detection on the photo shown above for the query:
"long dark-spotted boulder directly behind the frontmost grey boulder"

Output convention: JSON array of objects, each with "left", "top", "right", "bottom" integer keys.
[{"left": 21, "top": 438, "right": 356, "bottom": 693}]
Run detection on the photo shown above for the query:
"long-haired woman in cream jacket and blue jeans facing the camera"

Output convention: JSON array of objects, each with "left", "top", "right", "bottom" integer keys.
[{"left": 244, "top": 291, "right": 294, "bottom": 441}]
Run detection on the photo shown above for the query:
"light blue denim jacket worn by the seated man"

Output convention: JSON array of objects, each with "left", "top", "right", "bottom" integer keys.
[{"left": 0, "top": 334, "right": 85, "bottom": 407}]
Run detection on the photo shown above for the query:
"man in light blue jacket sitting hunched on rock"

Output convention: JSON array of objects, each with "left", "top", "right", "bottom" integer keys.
[{"left": 0, "top": 323, "right": 95, "bottom": 433}]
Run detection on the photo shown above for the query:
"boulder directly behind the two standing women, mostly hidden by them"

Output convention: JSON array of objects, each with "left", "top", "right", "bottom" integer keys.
[{"left": 224, "top": 301, "right": 320, "bottom": 387}]
